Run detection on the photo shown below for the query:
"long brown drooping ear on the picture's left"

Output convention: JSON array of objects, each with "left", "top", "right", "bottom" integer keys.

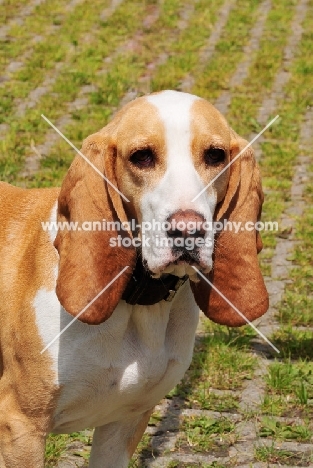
[{"left": 55, "top": 131, "right": 136, "bottom": 324}]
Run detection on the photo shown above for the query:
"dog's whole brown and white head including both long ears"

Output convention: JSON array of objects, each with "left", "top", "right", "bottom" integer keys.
[{"left": 55, "top": 91, "right": 268, "bottom": 326}]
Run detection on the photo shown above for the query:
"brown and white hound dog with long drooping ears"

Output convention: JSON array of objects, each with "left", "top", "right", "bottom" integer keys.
[{"left": 0, "top": 91, "right": 268, "bottom": 468}]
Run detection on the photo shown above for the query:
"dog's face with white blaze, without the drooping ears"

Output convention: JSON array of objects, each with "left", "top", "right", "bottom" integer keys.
[{"left": 112, "top": 91, "right": 233, "bottom": 277}]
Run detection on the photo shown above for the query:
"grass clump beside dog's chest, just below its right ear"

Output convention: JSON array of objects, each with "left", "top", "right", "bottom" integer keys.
[{"left": 169, "top": 321, "right": 256, "bottom": 411}]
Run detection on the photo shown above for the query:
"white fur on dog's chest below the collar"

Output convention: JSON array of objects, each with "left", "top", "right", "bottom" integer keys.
[{"left": 34, "top": 283, "right": 198, "bottom": 432}]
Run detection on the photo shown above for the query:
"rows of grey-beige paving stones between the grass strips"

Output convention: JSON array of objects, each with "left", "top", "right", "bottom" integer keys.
[{"left": 0, "top": 0, "right": 313, "bottom": 468}]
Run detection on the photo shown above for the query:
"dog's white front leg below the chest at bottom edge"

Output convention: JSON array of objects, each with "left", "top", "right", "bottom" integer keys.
[{"left": 89, "top": 409, "right": 153, "bottom": 468}]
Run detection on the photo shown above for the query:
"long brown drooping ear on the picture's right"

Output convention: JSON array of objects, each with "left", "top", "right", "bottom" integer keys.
[{"left": 192, "top": 134, "right": 268, "bottom": 327}]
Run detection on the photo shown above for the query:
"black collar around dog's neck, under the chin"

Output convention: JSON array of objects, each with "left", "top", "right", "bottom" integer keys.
[{"left": 122, "top": 257, "right": 188, "bottom": 305}]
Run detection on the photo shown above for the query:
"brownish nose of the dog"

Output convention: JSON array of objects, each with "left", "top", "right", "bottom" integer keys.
[{"left": 167, "top": 210, "right": 205, "bottom": 239}]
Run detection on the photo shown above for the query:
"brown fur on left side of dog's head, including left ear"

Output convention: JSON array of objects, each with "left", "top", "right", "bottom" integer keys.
[{"left": 55, "top": 98, "right": 166, "bottom": 324}]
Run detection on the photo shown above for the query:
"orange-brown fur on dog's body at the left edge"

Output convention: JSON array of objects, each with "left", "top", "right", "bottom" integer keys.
[{"left": 0, "top": 183, "right": 58, "bottom": 467}]
